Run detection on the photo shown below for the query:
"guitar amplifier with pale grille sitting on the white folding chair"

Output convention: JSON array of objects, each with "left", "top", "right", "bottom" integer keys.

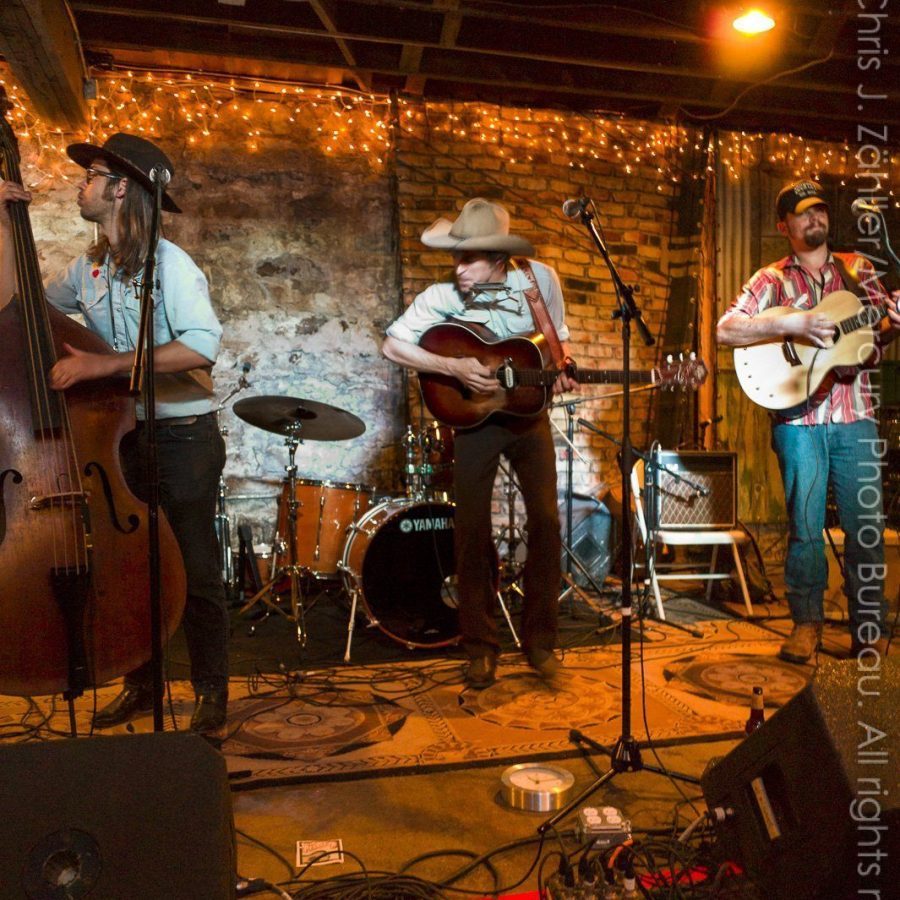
[{"left": 646, "top": 450, "right": 737, "bottom": 531}]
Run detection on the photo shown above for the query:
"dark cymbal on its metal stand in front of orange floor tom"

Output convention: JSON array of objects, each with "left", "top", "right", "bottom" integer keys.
[{"left": 233, "top": 395, "right": 366, "bottom": 648}]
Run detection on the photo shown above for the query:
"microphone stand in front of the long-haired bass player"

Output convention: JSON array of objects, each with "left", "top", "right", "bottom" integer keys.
[{"left": 129, "top": 166, "right": 171, "bottom": 731}]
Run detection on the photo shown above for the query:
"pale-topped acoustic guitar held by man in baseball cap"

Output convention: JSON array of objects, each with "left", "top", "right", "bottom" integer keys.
[{"left": 734, "top": 291, "right": 887, "bottom": 418}]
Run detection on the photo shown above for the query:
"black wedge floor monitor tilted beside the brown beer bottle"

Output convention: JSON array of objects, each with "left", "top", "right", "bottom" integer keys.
[{"left": 701, "top": 657, "right": 900, "bottom": 900}]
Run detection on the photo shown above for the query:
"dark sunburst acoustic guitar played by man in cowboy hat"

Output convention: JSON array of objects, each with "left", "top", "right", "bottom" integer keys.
[{"left": 419, "top": 319, "right": 707, "bottom": 428}]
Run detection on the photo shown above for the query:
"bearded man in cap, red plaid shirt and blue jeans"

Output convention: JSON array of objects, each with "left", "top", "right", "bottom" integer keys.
[{"left": 716, "top": 180, "right": 900, "bottom": 663}]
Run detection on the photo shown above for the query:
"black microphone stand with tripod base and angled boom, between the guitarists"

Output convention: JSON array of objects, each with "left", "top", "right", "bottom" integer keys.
[{"left": 538, "top": 204, "right": 700, "bottom": 835}]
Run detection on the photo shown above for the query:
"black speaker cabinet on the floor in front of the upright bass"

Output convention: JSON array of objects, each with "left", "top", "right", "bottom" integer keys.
[{"left": 0, "top": 733, "right": 236, "bottom": 900}]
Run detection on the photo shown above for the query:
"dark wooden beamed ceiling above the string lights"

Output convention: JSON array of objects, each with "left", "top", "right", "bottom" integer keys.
[{"left": 0, "top": 0, "right": 900, "bottom": 141}]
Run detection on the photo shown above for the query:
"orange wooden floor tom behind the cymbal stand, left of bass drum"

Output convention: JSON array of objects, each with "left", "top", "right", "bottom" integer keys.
[{"left": 278, "top": 478, "right": 373, "bottom": 579}]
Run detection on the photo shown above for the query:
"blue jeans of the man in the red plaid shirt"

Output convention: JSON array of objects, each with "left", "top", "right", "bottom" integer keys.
[{"left": 772, "top": 420, "right": 887, "bottom": 643}]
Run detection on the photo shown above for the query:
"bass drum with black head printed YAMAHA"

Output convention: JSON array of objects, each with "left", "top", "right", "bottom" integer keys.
[{"left": 341, "top": 499, "right": 459, "bottom": 648}]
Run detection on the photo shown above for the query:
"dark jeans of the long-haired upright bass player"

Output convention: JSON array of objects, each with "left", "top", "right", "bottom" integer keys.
[{"left": 121, "top": 413, "right": 228, "bottom": 691}]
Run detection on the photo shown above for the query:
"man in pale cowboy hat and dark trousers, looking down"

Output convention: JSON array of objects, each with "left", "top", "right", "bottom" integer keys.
[{"left": 383, "top": 198, "right": 577, "bottom": 688}]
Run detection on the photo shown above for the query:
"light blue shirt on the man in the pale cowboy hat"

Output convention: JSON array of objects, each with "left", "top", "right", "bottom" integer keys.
[{"left": 387, "top": 260, "right": 569, "bottom": 344}]
